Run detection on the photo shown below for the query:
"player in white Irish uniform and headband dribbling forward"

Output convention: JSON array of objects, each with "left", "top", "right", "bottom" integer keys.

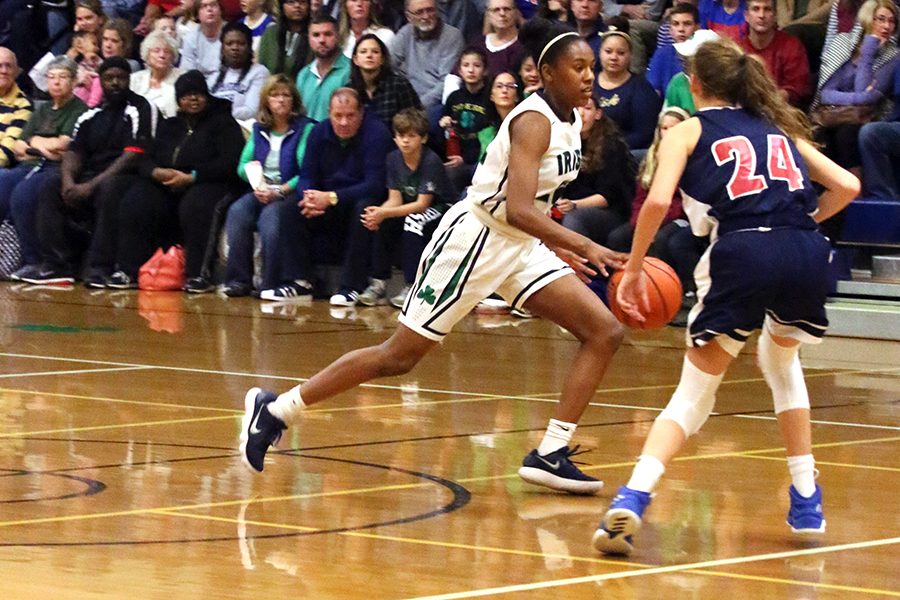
[{"left": 241, "top": 19, "right": 626, "bottom": 494}]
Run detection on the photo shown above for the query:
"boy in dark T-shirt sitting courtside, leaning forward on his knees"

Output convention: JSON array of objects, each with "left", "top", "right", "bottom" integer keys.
[{"left": 359, "top": 108, "right": 455, "bottom": 308}]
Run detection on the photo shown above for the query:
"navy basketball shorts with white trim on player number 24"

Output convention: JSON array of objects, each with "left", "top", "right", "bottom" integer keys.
[{"left": 687, "top": 228, "right": 831, "bottom": 356}]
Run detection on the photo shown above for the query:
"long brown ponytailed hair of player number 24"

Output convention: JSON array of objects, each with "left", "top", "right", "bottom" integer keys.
[{"left": 690, "top": 38, "right": 812, "bottom": 140}]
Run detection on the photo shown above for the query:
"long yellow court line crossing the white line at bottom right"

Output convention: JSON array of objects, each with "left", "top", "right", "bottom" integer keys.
[{"left": 154, "top": 510, "right": 900, "bottom": 597}]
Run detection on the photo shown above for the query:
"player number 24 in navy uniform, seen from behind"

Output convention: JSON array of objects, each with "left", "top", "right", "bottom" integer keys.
[{"left": 593, "top": 35, "right": 859, "bottom": 555}]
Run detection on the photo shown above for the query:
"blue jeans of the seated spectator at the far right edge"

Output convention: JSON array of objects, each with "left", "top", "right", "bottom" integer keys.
[{"left": 859, "top": 121, "right": 900, "bottom": 202}]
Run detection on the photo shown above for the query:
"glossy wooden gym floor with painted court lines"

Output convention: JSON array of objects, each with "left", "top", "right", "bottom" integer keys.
[{"left": 0, "top": 284, "right": 900, "bottom": 600}]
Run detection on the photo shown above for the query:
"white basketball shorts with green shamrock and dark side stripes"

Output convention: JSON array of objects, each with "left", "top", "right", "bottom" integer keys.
[{"left": 399, "top": 201, "right": 574, "bottom": 342}]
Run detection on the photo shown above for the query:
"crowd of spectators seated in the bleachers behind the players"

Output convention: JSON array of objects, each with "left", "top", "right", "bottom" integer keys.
[{"left": 0, "top": 0, "right": 900, "bottom": 307}]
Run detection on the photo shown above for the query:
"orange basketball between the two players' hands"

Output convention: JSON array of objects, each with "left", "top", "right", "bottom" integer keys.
[{"left": 607, "top": 256, "right": 682, "bottom": 329}]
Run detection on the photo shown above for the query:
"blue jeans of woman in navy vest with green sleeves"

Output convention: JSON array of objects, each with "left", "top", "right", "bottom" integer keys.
[{"left": 225, "top": 192, "right": 309, "bottom": 290}]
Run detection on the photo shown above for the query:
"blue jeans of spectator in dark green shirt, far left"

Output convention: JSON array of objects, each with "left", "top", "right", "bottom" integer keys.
[{"left": 0, "top": 163, "right": 59, "bottom": 265}]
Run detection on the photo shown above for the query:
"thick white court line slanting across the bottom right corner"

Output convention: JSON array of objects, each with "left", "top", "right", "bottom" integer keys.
[{"left": 404, "top": 537, "right": 900, "bottom": 600}]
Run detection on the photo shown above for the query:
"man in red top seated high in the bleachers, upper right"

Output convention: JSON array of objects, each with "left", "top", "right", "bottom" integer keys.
[{"left": 740, "top": 0, "right": 810, "bottom": 106}]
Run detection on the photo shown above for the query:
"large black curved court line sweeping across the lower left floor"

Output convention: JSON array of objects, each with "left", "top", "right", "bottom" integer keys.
[{"left": 0, "top": 452, "right": 472, "bottom": 548}]
